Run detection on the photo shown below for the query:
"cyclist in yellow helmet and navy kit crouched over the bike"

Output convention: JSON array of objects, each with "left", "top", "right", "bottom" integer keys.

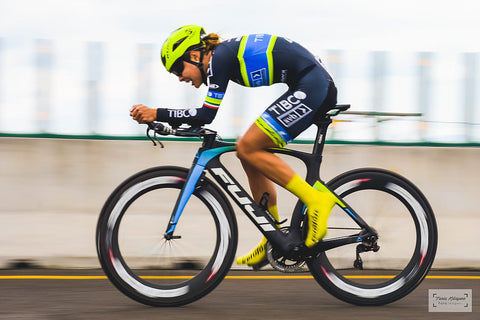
[{"left": 130, "top": 25, "right": 337, "bottom": 266}]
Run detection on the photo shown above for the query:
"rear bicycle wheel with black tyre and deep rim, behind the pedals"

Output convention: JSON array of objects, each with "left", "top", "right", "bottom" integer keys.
[{"left": 307, "top": 169, "right": 437, "bottom": 305}]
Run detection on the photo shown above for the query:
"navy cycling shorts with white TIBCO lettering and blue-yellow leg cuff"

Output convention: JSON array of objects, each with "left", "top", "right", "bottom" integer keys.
[{"left": 255, "top": 66, "right": 337, "bottom": 148}]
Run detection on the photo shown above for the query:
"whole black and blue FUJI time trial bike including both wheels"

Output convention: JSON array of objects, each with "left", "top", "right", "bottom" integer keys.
[{"left": 96, "top": 105, "right": 437, "bottom": 306}]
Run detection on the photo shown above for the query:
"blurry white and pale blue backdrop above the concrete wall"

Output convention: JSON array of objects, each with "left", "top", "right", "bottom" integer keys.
[{"left": 0, "top": 0, "right": 480, "bottom": 143}]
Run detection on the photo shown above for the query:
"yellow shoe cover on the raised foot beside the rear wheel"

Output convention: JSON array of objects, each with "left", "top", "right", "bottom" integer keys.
[{"left": 305, "top": 192, "right": 336, "bottom": 247}]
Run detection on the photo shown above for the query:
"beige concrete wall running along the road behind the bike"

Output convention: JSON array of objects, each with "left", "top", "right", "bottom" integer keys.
[{"left": 0, "top": 138, "right": 480, "bottom": 268}]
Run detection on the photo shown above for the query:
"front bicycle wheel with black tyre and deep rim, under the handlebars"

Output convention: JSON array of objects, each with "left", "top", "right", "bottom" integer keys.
[{"left": 96, "top": 167, "right": 238, "bottom": 306}]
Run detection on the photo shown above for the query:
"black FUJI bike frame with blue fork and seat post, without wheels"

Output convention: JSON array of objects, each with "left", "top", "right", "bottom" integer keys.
[{"left": 165, "top": 115, "right": 377, "bottom": 257}]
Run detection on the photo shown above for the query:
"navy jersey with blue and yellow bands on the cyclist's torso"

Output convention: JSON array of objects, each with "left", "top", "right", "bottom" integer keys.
[{"left": 204, "top": 34, "right": 319, "bottom": 109}]
